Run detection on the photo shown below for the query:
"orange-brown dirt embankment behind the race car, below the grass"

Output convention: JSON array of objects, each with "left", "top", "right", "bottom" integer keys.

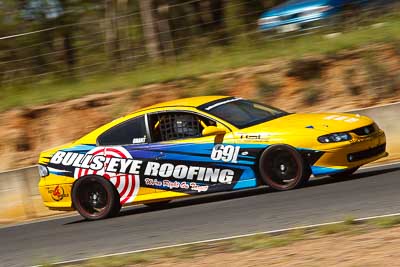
[{"left": 0, "top": 45, "right": 400, "bottom": 170}]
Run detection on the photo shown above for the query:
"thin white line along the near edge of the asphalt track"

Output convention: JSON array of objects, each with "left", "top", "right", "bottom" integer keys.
[{"left": 31, "top": 213, "right": 400, "bottom": 267}]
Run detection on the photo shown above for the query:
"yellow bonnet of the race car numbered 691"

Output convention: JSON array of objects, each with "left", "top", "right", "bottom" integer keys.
[{"left": 246, "top": 113, "right": 373, "bottom": 135}]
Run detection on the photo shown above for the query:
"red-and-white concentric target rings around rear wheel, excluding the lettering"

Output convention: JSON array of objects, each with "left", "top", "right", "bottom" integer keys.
[{"left": 74, "top": 147, "right": 140, "bottom": 204}]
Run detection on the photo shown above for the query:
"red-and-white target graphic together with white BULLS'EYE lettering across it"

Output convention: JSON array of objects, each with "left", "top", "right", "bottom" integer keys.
[{"left": 50, "top": 147, "right": 142, "bottom": 204}]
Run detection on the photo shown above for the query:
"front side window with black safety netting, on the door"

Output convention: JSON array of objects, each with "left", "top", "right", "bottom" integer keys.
[{"left": 149, "top": 112, "right": 216, "bottom": 142}]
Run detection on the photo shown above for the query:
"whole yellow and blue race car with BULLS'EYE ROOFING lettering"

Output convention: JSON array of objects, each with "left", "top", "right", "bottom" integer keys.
[{"left": 39, "top": 96, "right": 387, "bottom": 220}]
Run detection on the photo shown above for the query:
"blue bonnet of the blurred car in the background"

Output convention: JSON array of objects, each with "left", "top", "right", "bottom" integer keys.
[{"left": 261, "top": 0, "right": 330, "bottom": 17}]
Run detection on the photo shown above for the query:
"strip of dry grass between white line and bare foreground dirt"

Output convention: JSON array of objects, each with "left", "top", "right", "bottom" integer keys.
[{"left": 38, "top": 216, "right": 400, "bottom": 267}]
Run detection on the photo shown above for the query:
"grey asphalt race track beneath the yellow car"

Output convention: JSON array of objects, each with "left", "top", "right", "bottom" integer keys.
[{"left": 0, "top": 163, "right": 400, "bottom": 266}]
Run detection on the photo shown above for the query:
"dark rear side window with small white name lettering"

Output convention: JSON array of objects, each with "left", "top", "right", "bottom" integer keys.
[{"left": 97, "top": 117, "right": 148, "bottom": 146}]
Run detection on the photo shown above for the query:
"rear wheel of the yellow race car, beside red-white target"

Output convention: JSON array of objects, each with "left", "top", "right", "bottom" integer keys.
[{"left": 72, "top": 176, "right": 121, "bottom": 220}]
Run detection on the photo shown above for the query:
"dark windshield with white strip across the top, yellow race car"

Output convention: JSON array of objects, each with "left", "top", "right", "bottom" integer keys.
[{"left": 199, "top": 98, "right": 289, "bottom": 129}]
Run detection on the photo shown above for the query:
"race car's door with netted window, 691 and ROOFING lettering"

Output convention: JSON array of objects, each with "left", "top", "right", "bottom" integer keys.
[{"left": 144, "top": 111, "right": 243, "bottom": 194}]
